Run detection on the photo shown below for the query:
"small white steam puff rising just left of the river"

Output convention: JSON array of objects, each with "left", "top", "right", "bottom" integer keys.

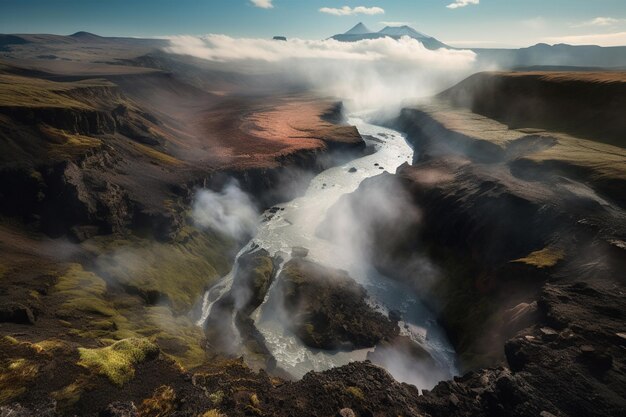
[{"left": 192, "top": 181, "right": 258, "bottom": 240}]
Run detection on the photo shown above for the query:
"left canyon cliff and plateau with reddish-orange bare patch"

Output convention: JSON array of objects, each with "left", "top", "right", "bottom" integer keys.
[{"left": 0, "top": 73, "right": 364, "bottom": 240}]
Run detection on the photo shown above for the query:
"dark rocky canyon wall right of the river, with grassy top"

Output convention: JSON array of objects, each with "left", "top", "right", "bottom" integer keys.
[{"left": 322, "top": 83, "right": 626, "bottom": 416}]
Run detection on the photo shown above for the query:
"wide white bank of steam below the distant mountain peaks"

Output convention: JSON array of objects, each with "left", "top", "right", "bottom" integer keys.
[{"left": 166, "top": 35, "right": 475, "bottom": 111}]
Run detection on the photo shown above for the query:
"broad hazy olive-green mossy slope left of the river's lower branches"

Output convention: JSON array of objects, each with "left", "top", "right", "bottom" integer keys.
[{"left": 42, "top": 221, "right": 234, "bottom": 369}]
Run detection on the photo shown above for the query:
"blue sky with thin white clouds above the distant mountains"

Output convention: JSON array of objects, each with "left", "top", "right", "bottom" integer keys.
[{"left": 0, "top": 0, "right": 626, "bottom": 47}]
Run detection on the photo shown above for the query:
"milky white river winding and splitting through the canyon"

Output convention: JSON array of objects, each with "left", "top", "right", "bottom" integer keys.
[{"left": 199, "top": 117, "right": 457, "bottom": 389}]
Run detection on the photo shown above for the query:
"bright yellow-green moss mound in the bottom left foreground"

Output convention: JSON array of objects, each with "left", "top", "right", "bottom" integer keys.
[{"left": 78, "top": 338, "right": 159, "bottom": 386}]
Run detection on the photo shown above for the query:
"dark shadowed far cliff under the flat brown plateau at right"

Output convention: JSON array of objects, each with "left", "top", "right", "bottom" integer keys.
[{"left": 440, "top": 72, "right": 626, "bottom": 148}]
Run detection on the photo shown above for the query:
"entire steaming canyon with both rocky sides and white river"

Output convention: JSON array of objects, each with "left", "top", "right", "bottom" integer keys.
[{"left": 0, "top": 33, "right": 626, "bottom": 417}]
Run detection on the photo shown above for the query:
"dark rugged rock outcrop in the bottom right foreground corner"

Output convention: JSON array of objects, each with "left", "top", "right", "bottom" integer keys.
[{"left": 420, "top": 282, "right": 626, "bottom": 416}]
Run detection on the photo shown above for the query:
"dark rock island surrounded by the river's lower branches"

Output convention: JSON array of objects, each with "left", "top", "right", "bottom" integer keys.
[{"left": 280, "top": 259, "right": 399, "bottom": 349}]
